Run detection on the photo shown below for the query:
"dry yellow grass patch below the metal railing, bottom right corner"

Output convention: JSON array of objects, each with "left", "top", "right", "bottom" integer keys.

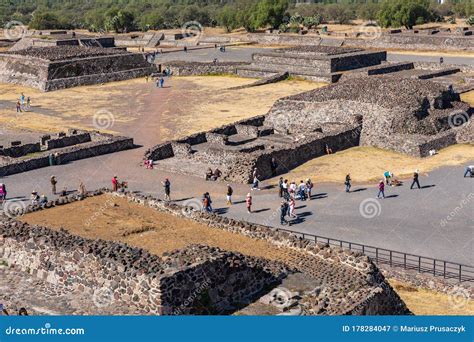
[{"left": 389, "top": 279, "right": 474, "bottom": 316}]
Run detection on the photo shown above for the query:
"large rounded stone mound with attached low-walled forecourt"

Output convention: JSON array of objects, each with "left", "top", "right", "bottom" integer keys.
[{"left": 145, "top": 76, "right": 474, "bottom": 183}]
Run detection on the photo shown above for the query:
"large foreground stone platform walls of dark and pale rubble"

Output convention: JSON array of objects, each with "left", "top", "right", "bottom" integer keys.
[{"left": 0, "top": 191, "right": 410, "bottom": 315}]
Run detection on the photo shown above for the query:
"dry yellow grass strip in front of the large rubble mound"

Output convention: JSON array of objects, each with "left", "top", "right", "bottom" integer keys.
[{"left": 274, "top": 144, "right": 474, "bottom": 184}]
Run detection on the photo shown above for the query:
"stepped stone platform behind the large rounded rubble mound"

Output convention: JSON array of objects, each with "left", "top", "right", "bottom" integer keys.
[{"left": 236, "top": 46, "right": 387, "bottom": 83}]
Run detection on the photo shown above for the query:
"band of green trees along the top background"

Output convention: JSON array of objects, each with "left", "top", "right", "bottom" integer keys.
[{"left": 0, "top": 0, "right": 474, "bottom": 32}]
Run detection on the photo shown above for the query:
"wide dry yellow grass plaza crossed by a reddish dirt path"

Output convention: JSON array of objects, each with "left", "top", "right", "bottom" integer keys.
[{"left": 0, "top": 76, "right": 324, "bottom": 139}]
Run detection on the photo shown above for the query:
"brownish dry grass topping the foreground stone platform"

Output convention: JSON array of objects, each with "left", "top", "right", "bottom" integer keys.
[{"left": 21, "top": 195, "right": 304, "bottom": 260}]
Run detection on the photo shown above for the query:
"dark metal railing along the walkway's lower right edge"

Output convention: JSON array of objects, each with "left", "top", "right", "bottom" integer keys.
[{"left": 275, "top": 228, "right": 474, "bottom": 282}]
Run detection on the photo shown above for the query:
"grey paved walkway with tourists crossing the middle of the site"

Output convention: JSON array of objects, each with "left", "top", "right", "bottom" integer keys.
[{"left": 2, "top": 144, "right": 474, "bottom": 265}]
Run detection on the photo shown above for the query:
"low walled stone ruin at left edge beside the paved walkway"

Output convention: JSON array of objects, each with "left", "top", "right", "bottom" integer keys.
[{"left": 0, "top": 129, "right": 135, "bottom": 177}]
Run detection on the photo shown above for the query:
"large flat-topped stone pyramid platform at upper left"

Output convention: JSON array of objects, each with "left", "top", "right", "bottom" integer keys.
[{"left": 0, "top": 45, "right": 156, "bottom": 91}]
